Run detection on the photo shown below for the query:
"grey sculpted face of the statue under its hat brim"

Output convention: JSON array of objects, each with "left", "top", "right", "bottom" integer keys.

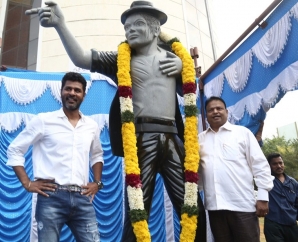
[{"left": 124, "top": 14, "right": 154, "bottom": 49}]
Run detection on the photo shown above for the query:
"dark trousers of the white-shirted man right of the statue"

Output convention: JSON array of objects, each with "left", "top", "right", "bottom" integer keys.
[{"left": 208, "top": 210, "right": 260, "bottom": 242}]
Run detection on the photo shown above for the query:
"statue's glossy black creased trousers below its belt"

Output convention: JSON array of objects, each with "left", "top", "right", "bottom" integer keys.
[{"left": 122, "top": 133, "right": 206, "bottom": 242}]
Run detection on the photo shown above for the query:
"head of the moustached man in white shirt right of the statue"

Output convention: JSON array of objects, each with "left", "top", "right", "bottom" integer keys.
[{"left": 206, "top": 100, "right": 228, "bottom": 131}]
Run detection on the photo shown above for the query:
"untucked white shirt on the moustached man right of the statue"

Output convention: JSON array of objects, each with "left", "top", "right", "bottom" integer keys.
[{"left": 199, "top": 122, "right": 274, "bottom": 212}]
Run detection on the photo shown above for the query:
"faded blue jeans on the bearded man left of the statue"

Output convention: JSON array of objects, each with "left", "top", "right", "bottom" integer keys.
[{"left": 35, "top": 190, "right": 99, "bottom": 242}]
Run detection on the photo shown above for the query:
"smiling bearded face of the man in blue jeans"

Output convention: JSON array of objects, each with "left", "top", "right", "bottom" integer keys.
[{"left": 61, "top": 81, "right": 85, "bottom": 111}]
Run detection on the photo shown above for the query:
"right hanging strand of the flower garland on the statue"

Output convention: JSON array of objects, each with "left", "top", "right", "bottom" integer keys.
[{"left": 169, "top": 40, "right": 200, "bottom": 242}]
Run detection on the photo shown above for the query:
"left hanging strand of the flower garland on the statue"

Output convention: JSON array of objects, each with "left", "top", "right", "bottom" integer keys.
[{"left": 117, "top": 42, "right": 151, "bottom": 242}]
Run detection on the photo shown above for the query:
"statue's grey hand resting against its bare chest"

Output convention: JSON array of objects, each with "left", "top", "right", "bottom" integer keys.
[{"left": 159, "top": 51, "right": 182, "bottom": 76}]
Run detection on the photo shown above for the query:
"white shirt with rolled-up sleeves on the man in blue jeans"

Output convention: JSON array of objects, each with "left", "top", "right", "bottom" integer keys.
[{"left": 7, "top": 108, "right": 104, "bottom": 186}]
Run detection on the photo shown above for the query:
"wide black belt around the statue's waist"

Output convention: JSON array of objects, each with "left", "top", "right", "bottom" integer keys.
[{"left": 135, "top": 117, "right": 178, "bottom": 134}]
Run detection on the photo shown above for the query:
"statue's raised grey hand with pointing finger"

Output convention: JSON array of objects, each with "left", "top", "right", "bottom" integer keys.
[{"left": 25, "top": 1, "right": 64, "bottom": 28}]
